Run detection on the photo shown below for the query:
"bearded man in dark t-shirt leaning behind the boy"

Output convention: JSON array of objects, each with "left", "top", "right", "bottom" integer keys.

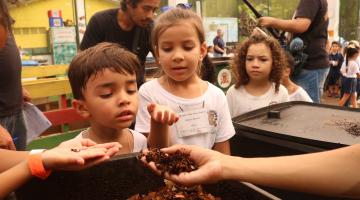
[{"left": 80, "top": 0, "right": 160, "bottom": 87}]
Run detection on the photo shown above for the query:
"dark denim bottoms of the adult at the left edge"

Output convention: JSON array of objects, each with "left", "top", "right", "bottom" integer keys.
[{"left": 0, "top": 110, "right": 26, "bottom": 151}]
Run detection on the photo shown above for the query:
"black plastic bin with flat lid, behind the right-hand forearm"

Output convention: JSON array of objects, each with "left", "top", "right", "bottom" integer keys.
[{"left": 230, "top": 102, "right": 360, "bottom": 200}]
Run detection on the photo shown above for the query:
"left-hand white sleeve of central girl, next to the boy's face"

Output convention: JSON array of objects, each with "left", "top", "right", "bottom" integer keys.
[{"left": 135, "top": 85, "right": 152, "bottom": 133}]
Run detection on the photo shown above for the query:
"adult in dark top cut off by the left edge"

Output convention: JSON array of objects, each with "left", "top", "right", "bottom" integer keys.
[{"left": 0, "top": 0, "right": 30, "bottom": 150}]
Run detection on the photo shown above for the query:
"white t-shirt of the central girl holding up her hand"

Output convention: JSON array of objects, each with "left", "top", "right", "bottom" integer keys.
[{"left": 135, "top": 79, "right": 235, "bottom": 149}]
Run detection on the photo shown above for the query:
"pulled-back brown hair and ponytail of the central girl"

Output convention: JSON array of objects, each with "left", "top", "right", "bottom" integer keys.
[{"left": 151, "top": 8, "right": 215, "bottom": 83}]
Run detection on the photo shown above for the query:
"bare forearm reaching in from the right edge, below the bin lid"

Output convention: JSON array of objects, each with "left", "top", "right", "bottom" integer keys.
[{"left": 228, "top": 145, "right": 360, "bottom": 198}]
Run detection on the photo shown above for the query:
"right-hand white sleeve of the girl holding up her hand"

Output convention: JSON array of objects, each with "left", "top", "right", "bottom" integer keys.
[{"left": 215, "top": 90, "right": 235, "bottom": 143}]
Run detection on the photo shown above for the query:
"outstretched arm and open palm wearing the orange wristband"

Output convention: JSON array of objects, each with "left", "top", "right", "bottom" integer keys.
[{"left": 0, "top": 140, "right": 121, "bottom": 199}]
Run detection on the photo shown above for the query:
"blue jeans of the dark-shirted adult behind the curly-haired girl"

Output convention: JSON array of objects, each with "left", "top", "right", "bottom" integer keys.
[{"left": 294, "top": 68, "right": 330, "bottom": 103}]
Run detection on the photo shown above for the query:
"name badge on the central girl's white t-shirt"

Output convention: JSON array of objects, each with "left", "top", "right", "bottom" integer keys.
[{"left": 175, "top": 109, "right": 212, "bottom": 138}]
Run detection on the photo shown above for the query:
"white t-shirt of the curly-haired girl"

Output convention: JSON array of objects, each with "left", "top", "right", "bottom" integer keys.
[{"left": 226, "top": 84, "right": 289, "bottom": 117}]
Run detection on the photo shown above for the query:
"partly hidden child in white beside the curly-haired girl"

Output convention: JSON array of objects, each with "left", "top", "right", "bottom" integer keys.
[{"left": 281, "top": 52, "right": 313, "bottom": 102}]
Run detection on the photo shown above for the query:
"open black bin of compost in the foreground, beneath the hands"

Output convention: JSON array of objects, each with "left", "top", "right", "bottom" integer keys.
[{"left": 16, "top": 154, "right": 279, "bottom": 200}]
